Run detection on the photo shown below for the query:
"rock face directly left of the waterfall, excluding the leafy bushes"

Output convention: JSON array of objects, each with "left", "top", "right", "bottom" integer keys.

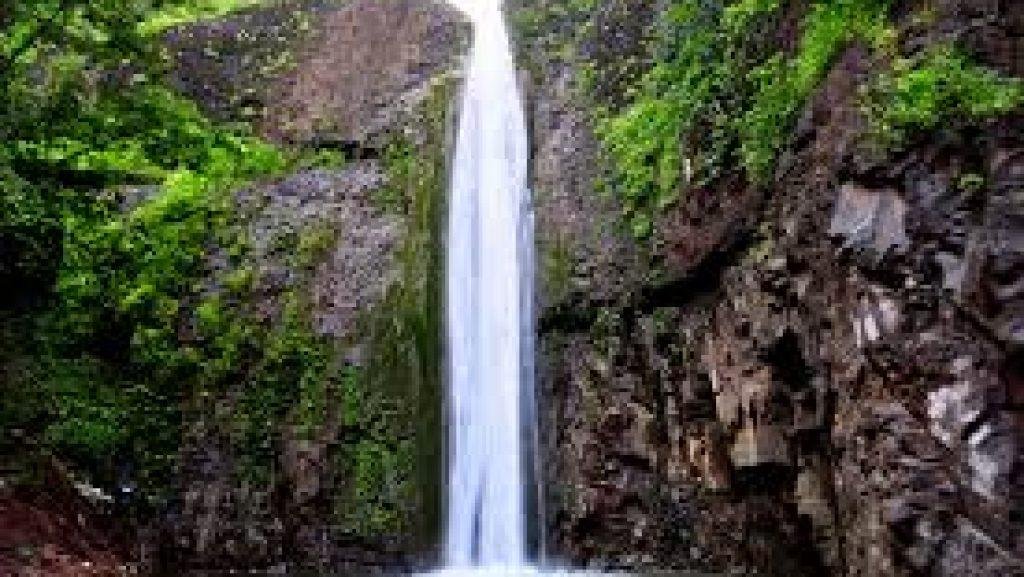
[{"left": 160, "top": 0, "right": 468, "bottom": 574}]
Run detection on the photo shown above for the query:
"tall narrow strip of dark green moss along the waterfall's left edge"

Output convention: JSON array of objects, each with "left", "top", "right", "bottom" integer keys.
[{"left": 335, "top": 77, "right": 455, "bottom": 546}]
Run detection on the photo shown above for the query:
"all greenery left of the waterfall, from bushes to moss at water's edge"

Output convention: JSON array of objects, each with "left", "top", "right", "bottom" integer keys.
[{"left": 0, "top": 0, "right": 454, "bottom": 538}]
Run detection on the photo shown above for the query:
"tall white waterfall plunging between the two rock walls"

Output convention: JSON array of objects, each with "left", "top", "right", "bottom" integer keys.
[{"left": 445, "top": 0, "right": 534, "bottom": 568}]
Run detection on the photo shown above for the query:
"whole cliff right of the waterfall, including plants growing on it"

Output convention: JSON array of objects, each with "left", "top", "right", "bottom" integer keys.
[{"left": 520, "top": 0, "right": 1024, "bottom": 576}]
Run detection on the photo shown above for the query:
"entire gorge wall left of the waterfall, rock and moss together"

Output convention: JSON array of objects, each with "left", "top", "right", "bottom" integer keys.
[{"left": 0, "top": 0, "right": 469, "bottom": 575}]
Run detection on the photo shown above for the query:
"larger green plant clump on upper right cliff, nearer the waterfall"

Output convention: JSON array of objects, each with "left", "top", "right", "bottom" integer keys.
[{"left": 598, "top": 0, "right": 891, "bottom": 238}]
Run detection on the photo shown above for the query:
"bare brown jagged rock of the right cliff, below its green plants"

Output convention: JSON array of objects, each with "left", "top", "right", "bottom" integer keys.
[{"left": 521, "top": 1, "right": 1024, "bottom": 576}]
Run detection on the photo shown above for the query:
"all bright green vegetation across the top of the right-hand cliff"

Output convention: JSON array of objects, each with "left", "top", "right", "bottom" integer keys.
[{"left": 585, "top": 0, "right": 1024, "bottom": 238}]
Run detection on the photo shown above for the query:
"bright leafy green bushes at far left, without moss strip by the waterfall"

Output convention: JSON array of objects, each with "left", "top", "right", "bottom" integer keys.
[{"left": 0, "top": 0, "right": 360, "bottom": 501}]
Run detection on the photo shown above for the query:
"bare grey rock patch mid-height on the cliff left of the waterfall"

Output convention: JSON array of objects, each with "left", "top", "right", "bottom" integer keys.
[{"left": 238, "top": 160, "right": 404, "bottom": 339}]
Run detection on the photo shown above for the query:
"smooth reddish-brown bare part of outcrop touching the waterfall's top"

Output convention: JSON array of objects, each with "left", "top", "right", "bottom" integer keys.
[{"left": 267, "top": 0, "right": 467, "bottom": 146}]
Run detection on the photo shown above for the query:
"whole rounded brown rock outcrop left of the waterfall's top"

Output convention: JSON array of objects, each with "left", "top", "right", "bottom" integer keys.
[{"left": 166, "top": 0, "right": 469, "bottom": 146}]
